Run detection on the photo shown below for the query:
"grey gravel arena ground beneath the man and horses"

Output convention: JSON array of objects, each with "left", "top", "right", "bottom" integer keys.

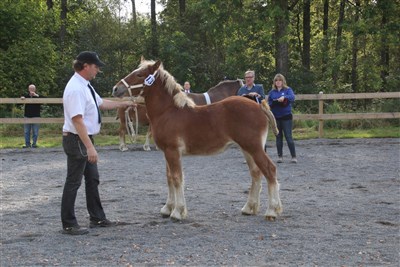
[{"left": 0, "top": 139, "right": 400, "bottom": 267}]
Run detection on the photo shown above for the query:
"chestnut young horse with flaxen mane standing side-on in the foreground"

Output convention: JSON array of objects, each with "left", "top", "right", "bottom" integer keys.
[{"left": 113, "top": 59, "right": 282, "bottom": 220}]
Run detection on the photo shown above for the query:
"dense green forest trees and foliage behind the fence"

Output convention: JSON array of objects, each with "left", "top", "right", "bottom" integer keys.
[{"left": 0, "top": 0, "right": 400, "bottom": 110}]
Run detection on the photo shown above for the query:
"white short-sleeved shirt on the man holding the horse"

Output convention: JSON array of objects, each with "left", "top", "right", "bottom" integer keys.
[{"left": 63, "top": 72, "right": 103, "bottom": 135}]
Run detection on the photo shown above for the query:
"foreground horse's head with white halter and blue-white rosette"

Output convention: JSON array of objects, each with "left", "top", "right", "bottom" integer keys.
[{"left": 112, "top": 57, "right": 161, "bottom": 97}]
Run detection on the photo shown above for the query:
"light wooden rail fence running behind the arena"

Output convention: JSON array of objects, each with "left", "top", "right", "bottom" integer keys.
[{"left": 0, "top": 92, "right": 400, "bottom": 138}]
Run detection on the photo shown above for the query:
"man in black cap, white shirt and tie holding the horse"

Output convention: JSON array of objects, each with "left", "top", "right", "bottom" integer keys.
[{"left": 61, "top": 51, "right": 136, "bottom": 235}]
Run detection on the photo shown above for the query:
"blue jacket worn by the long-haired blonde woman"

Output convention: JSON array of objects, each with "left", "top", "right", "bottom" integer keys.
[{"left": 268, "top": 87, "right": 296, "bottom": 119}]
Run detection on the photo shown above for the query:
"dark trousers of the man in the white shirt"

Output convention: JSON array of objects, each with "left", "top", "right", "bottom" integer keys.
[{"left": 61, "top": 134, "right": 106, "bottom": 227}]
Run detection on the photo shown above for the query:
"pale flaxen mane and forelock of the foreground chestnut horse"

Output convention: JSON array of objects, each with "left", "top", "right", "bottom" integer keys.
[{"left": 139, "top": 60, "right": 196, "bottom": 108}]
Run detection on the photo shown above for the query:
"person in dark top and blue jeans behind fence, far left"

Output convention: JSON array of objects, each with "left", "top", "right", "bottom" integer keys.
[{"left": 21, "top": 84, "right": 42, "bottom": 148}]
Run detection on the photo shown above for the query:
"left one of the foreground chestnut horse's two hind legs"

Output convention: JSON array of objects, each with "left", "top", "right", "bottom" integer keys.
[{"left": 242, "top": 151, "right": 262, "bottom": 215}]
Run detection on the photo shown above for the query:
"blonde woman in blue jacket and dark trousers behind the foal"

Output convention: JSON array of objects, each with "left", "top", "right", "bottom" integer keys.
[{"left": 268, "top": 73, "right": 297, "bottom": 163}]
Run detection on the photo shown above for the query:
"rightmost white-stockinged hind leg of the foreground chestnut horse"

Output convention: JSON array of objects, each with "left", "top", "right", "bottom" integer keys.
[{"left": 253, "top": 150, "right": 283, "bottom": 220}]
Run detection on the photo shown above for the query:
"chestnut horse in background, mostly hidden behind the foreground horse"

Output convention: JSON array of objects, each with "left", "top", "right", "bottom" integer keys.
[{"left": 117, "top": 79, "right": 243, "bottom": 151}]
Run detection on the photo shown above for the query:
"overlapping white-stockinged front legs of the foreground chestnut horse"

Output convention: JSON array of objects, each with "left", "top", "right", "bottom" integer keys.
[{"left": 161, "top": 150, "right": 187, "bottom": 220}]
